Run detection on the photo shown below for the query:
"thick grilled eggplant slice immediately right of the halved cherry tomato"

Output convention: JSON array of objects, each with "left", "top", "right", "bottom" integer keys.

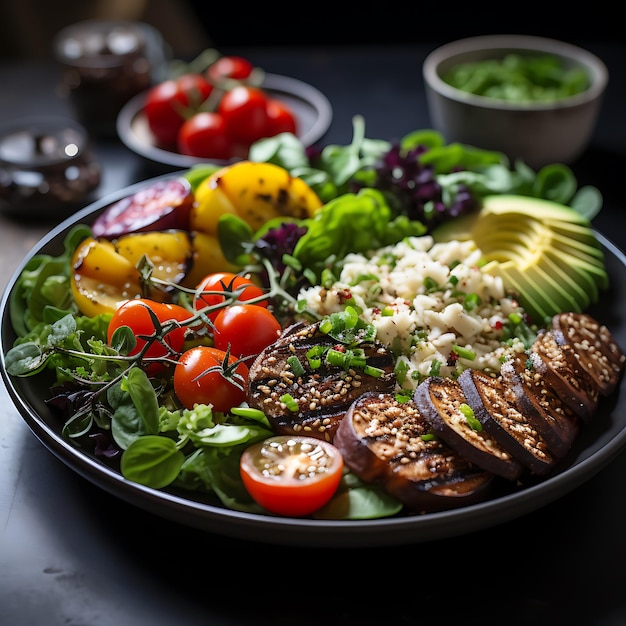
[{"left": 334, "top": 392, "right": 493, "bottom": 513}]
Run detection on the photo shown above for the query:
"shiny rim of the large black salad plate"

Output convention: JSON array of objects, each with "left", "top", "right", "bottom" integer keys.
[{"left": 0, "top": 172, "right": 626, "bottom": 548}]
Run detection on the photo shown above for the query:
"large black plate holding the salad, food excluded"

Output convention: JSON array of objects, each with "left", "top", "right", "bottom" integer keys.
[{"left": 0, "top": 173, "right": 626, "bottom": 547}]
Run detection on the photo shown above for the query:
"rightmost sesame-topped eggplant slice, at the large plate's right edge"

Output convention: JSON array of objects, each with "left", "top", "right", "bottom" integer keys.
[{"left": 552, "top": 313, "right": 626, "bottom": 396}]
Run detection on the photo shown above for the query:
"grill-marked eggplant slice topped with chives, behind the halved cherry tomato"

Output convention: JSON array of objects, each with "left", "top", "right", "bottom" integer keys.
[{"left": 247, "top": 322, "right": 396, "bottom": 442}]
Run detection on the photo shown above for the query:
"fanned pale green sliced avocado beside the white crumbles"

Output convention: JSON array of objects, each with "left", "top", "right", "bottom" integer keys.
[{"left": 431, "top": 195, "right": 608, "bottom": 323}]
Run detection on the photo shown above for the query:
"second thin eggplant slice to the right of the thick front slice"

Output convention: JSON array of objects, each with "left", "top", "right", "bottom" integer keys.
[{"left": 458, "top": 369, "right": 556, "bottom": 476}]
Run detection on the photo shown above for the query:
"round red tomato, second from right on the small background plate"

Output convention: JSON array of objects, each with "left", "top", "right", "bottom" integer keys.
[{"left": 217, "top": 85, "right": 268, "bottom": 147}]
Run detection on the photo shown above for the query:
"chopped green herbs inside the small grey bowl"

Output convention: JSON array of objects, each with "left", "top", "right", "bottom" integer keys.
[{"left": 442, "top": 53, "right": 590, "bottom": 103}]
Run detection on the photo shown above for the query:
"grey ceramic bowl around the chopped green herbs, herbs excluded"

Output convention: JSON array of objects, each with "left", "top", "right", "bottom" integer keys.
[{"left": 422, "top": 35, "right": 609, "bottom": 169}]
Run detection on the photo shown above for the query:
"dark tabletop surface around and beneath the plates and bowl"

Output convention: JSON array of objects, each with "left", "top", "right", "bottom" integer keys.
[{"left": 0, "top": 41, "right": 626, "bottom": 626}]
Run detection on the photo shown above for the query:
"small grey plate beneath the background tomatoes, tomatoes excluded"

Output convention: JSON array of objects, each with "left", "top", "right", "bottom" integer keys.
[{"left": 117, "top": 74, "right": 333, "bottom": 168}]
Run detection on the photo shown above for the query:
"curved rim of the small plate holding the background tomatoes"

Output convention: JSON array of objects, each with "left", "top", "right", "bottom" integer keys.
[{"left": 115, "top": 73, "right": 333, "bottom": 168}]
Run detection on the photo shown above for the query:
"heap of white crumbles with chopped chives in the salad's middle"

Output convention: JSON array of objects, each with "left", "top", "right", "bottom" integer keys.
[{"left": 299, "top": 235, "right": 524, "bottom": 389}]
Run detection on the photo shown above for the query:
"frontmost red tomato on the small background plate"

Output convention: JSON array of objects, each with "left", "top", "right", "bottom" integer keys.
[{"left": 177, "top": 111, "right": 233, "bottom": 160}]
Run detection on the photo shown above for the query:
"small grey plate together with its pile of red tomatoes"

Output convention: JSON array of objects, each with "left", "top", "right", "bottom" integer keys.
[{"left": 117, "top": 56, "right": 332, "bottom": 167}]
